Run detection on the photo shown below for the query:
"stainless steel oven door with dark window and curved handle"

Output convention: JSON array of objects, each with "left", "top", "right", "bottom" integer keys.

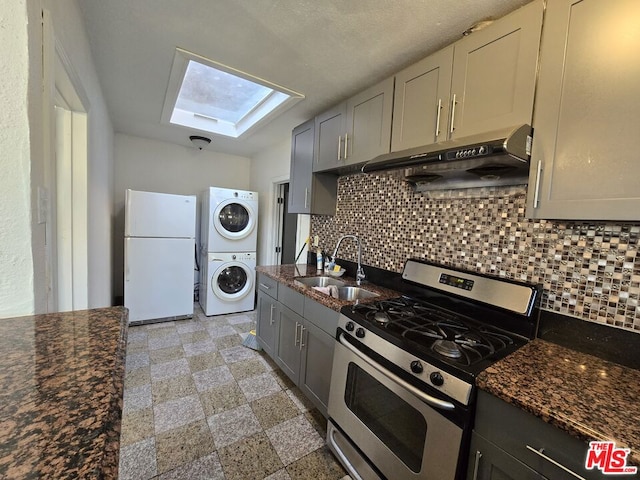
[{"left": 328, "top": 332, "right": 463, "bottom": 480}]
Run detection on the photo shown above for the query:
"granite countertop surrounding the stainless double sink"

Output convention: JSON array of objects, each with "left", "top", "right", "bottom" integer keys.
[{"left": 256, "top": 264, "right": 400, "bottom": 311}]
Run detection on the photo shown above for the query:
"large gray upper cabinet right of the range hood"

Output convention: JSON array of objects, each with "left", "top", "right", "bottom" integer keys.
[{"left": 527, "top": 0, "right": 640, "bottom": 220}]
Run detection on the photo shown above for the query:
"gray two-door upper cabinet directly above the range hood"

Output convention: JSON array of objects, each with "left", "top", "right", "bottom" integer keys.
[{"left": 391, "top": 0, "right": 544, "bottom": 152}]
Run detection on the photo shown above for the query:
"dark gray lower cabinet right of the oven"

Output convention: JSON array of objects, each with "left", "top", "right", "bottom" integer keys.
[{"left": 467, "top": 391, "right": 616, "bottom": 480}]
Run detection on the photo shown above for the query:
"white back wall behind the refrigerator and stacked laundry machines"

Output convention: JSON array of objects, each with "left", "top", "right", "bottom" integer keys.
[{"left": 112, "top": 133, "right": 251, "bottom": 296}]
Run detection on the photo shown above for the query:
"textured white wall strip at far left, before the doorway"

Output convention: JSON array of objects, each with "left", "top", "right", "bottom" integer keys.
[{"left": 0, "top": 0, "right": 35, "bottom": 317}]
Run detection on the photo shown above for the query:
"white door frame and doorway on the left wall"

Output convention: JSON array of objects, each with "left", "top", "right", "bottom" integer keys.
[{"left": 39, "top": 8, "right": 91, "bottom": 312}]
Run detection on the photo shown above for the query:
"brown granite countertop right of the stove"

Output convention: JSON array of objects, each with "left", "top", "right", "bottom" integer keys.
[{"left": 476, "top": 339, "right": 640, "bottom": 465}]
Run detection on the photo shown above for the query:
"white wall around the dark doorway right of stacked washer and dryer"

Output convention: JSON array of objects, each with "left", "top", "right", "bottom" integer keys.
[{"left": 251, "top": 135, "right": 310, "bottom": 265}]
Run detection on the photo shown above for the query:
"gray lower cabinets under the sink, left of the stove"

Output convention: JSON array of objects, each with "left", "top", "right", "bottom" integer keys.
[{"left": 257, "top": 274, "right": 339, "bottom": 417}]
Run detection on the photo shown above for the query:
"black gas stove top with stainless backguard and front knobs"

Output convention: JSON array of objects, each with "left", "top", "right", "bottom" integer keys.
[{"left": 339, "top": 259, "right": 540, "bottom": 384}]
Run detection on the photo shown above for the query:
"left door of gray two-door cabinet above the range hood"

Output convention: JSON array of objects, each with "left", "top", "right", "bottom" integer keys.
[{"left": 391, "top": 46, "right": 453, "bottom": 152}]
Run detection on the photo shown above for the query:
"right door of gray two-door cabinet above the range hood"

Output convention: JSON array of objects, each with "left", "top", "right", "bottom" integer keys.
[{"left": 447, "top": 0, "right": 553, "bottom": 138}]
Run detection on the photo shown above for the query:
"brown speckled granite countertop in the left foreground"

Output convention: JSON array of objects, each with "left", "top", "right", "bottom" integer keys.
[{"left": 0, "top": 307, "right": 128, "bottom": 479}]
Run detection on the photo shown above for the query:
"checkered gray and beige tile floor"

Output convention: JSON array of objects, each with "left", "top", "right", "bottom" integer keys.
[{"left": 119, "top": 305, "right": 349, "bottom": 480}]
